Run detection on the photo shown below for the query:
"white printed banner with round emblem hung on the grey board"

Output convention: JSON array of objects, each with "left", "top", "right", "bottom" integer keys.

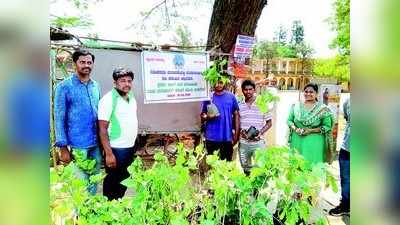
[{"left": 142, "top": 51, "right": 209, "bottom": 104}]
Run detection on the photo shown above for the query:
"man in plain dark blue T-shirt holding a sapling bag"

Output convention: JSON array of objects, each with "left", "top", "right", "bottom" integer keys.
[{"left": 200, "top": 80, "right": 239, "bottom": 161}]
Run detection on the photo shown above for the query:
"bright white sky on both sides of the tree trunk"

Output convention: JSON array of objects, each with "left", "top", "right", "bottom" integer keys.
[{"left": 50, "top": 0, "right": 335, "bottom": 57}]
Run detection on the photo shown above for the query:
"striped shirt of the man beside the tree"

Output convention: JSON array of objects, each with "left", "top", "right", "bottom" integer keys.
[{"left": 239, "top": 101, "right": 272, "bottom": 130}]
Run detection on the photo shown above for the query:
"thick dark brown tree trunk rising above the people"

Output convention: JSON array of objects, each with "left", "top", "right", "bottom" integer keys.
[{"left": 207, "top": 0, "right": 267, "bottom": 53}]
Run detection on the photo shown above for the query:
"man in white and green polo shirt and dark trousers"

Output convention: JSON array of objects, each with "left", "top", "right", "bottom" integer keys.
[{"left": 98, "top": 68, "right": 138, "bottom": 200}]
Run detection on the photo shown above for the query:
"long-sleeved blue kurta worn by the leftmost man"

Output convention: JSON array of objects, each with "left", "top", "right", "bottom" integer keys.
[{"left": 54, "top": 74, "right": 100, "bottom": 148}]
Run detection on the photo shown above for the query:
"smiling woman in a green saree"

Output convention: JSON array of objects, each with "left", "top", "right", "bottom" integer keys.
[{"left": 288, "top": 83, "right": 333, "bottom": 164}]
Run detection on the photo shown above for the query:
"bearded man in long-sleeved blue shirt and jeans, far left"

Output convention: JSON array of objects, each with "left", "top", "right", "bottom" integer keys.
[{"left": 54, "top": 50, "right": 101, "bottom": 195}]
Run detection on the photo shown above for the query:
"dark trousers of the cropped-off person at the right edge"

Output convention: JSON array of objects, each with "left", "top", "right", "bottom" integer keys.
[{"left": 339, "top": 149, "right": 350, "bottom": 209}]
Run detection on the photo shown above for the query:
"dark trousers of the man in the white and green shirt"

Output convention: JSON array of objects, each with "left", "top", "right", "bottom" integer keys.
[{"left": 103, "top": 147, "right": 135, "bottom": 200}]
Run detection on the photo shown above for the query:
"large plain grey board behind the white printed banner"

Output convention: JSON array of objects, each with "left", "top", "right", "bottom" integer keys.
[{"left": 88, "top": 49, "right": 201, "bottom": 134}]
